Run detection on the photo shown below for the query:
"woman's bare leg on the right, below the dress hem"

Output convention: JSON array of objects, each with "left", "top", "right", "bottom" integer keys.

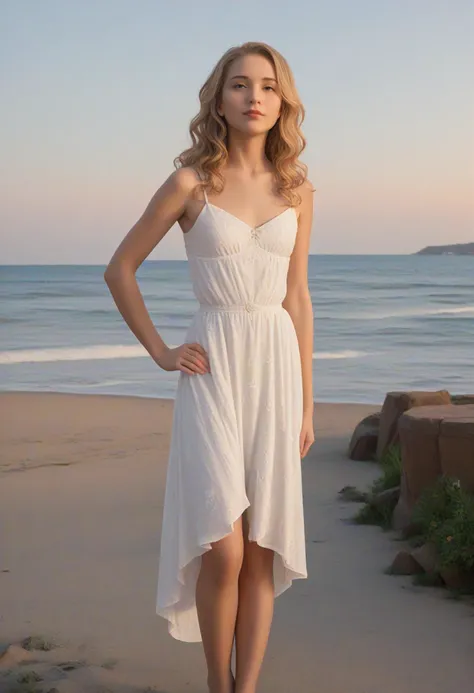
[{"left": 235, "top": 515, "right": 275, "bottom": 693}]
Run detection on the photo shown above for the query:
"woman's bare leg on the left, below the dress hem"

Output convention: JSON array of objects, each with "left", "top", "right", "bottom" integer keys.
[{"left": 196, "top": 517, "right": 243, "bottom": 693}]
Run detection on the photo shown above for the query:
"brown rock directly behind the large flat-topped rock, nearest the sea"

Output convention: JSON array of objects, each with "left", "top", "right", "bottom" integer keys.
[{"left": 376, "top": 390, "right": 451, "bottom": 460}]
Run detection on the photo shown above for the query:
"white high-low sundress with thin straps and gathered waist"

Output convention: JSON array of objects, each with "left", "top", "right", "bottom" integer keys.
[{"left": 156, "top": 184, "right": 307, "bottom": 642}]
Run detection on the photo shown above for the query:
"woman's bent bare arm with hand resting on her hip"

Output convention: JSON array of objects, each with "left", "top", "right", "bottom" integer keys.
[{"left": 104, "top": 168, "right": 209, "bottom": 375}]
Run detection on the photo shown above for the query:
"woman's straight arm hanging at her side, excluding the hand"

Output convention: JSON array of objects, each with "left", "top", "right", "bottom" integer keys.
[{"left": 283, "top": 181, "right": 313, "bottom": 418}]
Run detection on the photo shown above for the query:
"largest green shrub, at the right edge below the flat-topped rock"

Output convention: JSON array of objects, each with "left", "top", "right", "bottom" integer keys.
[{"left": 412, "top": 475, "right": 474, "bottom": 571}]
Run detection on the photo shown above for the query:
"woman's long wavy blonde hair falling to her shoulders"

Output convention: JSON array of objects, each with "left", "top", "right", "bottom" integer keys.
[{"left": 173, "top": 41, "right": 307, "bottom": 206}]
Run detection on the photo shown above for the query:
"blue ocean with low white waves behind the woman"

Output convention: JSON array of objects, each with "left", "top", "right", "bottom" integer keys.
[{"left": 0, "top": 255, "right": 474, "bottom": 404}]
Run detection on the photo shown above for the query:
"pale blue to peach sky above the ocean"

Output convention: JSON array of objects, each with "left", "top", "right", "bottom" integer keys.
[{"left": 0, "top": 0, "right": 474, "bottom": 265}]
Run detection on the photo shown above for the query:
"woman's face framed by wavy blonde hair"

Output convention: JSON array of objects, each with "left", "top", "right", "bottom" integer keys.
[{"left": 217, "top": 55, "right": 281, "bottom": 135}]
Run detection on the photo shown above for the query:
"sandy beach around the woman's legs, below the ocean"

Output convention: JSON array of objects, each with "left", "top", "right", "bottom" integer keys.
[{"left": 0, "top": 392, "right": 474, "bottom": 693}]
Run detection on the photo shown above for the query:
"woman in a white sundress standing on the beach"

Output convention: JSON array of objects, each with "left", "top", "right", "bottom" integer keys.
[{"left": 104, "top": 43, "right": 314, "bottom": 693}]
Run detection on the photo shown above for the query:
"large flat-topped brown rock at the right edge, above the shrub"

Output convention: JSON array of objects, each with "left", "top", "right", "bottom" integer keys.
[{"left": 393, "top": 404, "right": 474, "bottom": 529}]
